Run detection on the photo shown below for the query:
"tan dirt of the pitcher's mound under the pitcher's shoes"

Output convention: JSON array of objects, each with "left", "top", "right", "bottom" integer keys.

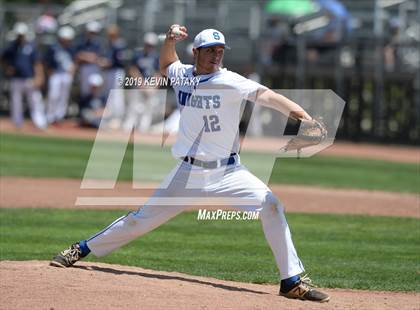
[{"left": 0, "top": 261, "right": 420, "bottom": 310}]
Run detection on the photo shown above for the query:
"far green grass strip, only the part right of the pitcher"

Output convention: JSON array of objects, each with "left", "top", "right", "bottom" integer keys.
[{"left": 270, "top": 156, "right": 420, "bottom": 194}]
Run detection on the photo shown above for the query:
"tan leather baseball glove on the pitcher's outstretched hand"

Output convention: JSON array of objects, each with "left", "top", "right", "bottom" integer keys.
[{"left": 282, "top": 119, "right": 328, "bottom": 158}]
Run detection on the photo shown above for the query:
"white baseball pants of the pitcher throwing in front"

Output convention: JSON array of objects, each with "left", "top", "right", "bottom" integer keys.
[{"left": 87, "top": 162, "right": 304, "bottom": 279}]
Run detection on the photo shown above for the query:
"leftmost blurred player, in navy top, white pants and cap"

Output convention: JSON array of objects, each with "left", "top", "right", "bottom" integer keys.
[{"left": 1, "top": 22, "right": 47, "bottom": 129}]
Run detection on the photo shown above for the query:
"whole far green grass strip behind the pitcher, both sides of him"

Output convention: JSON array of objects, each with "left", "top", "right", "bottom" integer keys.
[{"left": 0, "top": 134, "right": 420, "bottom": 193}]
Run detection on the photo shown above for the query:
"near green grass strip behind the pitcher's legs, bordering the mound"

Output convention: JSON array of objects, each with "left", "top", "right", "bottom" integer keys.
[{"left": 0, "top": 209, "right": 420, "bottom": 291}]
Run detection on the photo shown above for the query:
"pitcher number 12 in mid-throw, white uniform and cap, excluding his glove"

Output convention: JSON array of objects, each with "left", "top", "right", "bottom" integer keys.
[{"left": 51, "top": 25, "right": 329, "bottom": 302}]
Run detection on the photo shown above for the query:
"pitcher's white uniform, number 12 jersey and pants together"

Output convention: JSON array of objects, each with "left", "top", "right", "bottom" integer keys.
[{"left": 87, "top": 61, "right": 304, "bottom": 279}]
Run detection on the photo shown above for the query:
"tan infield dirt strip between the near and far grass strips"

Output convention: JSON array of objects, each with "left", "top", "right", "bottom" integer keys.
[{"left": 0, "top": 177, "right": 420, "bottom": 218}]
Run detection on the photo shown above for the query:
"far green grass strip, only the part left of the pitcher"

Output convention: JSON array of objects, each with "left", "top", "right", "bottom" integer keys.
[{"left": 0, "top": 134, "right": 175, "bottom": 182}]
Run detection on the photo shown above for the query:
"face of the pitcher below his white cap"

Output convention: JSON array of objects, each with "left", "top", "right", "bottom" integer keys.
[{"left": 194, "top": 45, "right": 225, "bottom": 74}]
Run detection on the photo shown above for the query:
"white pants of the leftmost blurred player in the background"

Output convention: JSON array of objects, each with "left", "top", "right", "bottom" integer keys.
[{"left": 10, "top": 79, "right": 47, "bottom": 129}]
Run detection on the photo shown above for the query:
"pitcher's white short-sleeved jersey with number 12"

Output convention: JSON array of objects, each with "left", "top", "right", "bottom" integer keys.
[{"left": 167, "top": 61, "right": 266, "bottom": 161}]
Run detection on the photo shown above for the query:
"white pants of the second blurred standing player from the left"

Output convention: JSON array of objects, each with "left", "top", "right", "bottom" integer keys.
[{"left": 47, "top": 72, "right": 73, "bottom": 123}]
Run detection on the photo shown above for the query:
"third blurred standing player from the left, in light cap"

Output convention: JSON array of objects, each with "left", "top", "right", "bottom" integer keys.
[{"left": 75, "top": 21, "right": 102, "bottom": 98}]
